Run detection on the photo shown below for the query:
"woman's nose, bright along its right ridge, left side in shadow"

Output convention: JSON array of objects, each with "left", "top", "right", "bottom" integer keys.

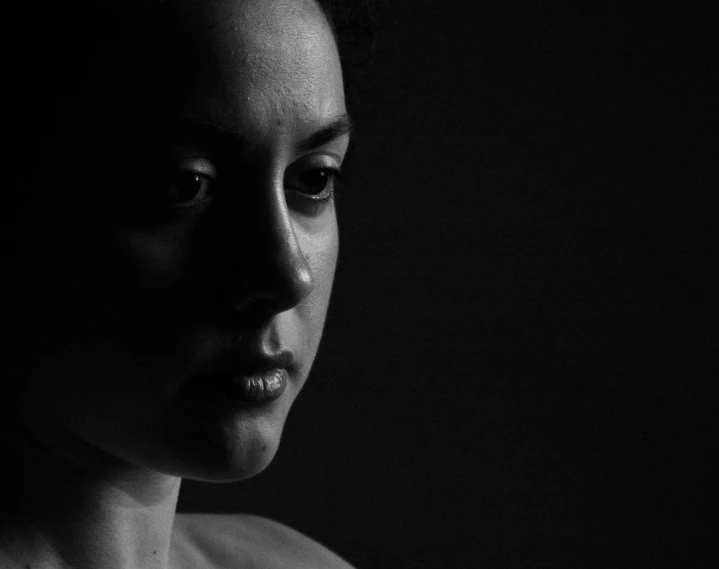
[{"left": 205, "top": 173, "right": 314, "bottom": 318}]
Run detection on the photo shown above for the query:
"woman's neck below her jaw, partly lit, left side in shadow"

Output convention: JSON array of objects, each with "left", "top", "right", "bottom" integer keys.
[{"left": 0, "top": 418, "right": 180, "bottom": 569}]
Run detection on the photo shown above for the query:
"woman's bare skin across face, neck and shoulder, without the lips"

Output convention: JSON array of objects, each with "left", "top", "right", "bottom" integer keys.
[{"left": 0, "top": 0, "right": 349, "bottom": 569}]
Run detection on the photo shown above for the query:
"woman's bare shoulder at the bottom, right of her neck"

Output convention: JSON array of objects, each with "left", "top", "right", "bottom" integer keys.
[{"left": 174, "top": 514, "right": 354, "bottom": 569}]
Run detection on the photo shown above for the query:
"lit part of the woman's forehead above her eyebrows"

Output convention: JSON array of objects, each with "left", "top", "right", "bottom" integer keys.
[{"left": 169, "top": 0, "right": 344, "bottom": 140}]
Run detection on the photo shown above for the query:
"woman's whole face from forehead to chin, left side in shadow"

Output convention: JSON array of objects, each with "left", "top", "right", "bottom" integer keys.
[{"left": 11, "top": 0, "right": 349, "bottom": 480}]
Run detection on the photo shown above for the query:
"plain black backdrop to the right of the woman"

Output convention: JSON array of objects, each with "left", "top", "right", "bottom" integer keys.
[{"left": 181, "top": 0, "right": 719, "bottom": 569}]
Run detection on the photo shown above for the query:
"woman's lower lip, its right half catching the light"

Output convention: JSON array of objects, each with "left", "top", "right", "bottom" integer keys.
[{"left": 187, "top": 368, "right": 289, "bottom": 405}]
